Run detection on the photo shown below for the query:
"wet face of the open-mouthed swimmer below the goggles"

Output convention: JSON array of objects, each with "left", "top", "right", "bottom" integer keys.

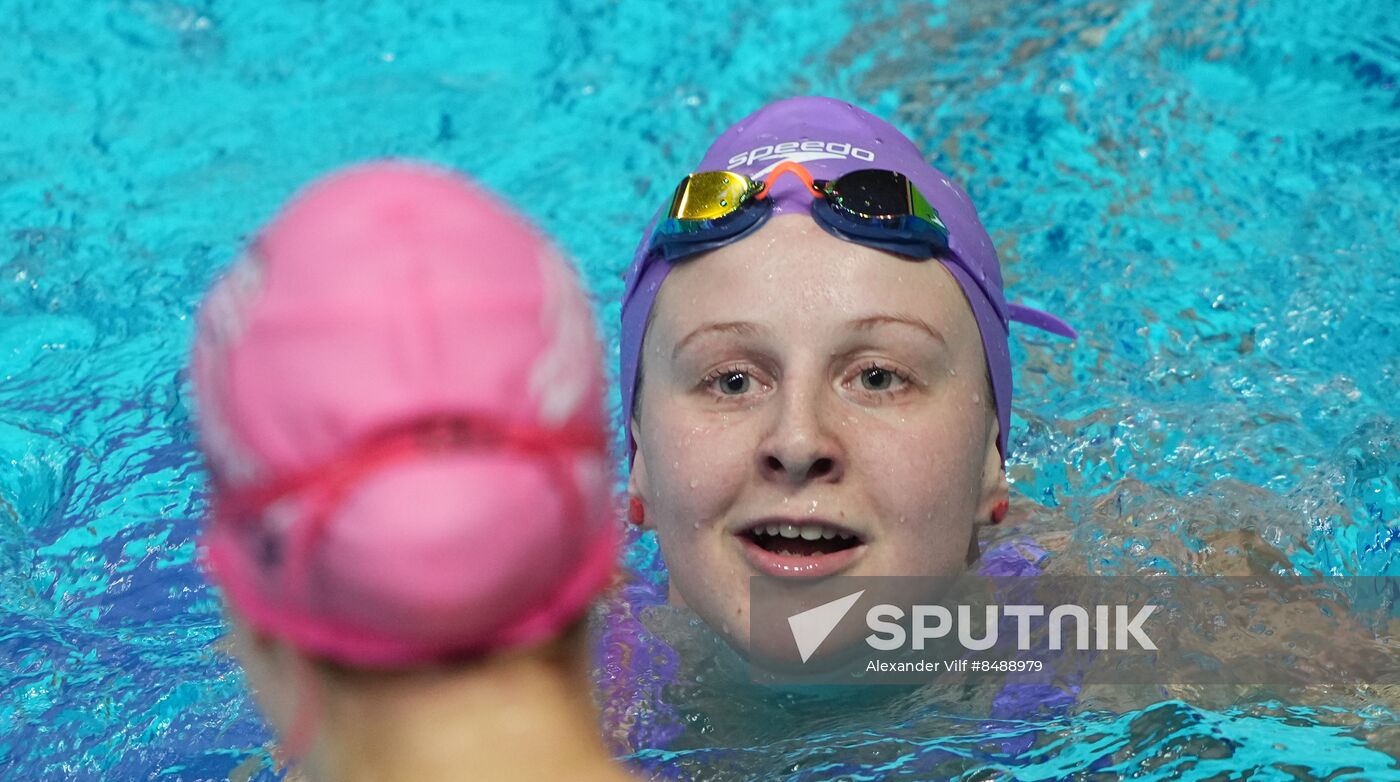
[{"left": 629, "top": 215, "right": 1007, "bottom": 660}]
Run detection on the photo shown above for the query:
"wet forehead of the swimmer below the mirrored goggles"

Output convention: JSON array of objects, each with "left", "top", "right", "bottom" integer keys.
[{"left": 652, "top": 214, "right": 980, "bottom": 353}]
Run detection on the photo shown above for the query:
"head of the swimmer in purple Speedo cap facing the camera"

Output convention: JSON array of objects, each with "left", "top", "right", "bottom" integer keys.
[{"left": 622, "top": 98, "right": 1074, "bottom": 660}]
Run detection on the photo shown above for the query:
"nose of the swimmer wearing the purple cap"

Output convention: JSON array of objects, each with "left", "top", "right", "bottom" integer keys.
[{"left": 759, "top": 394, "right": 846, "bottom": 485}]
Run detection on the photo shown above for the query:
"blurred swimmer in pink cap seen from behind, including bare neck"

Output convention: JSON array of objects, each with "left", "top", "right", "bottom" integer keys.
[{"left": 193, "top": 162, "right": 626, "bottom": 782}]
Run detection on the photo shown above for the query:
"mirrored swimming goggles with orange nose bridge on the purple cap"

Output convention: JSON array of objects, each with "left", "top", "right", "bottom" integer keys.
[{"left": 651, "top": 161, "right": 948, "bottom": 260}]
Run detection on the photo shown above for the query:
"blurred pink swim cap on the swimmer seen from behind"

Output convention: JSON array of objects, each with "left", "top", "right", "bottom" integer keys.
[{"left": 193, "top": 162, "right": 616, "bottom": 666}]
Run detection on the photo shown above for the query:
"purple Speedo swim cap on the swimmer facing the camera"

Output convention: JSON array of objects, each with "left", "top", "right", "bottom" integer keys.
[{"left": 622, "top": 97, "right": 1077, "bottom": 462}]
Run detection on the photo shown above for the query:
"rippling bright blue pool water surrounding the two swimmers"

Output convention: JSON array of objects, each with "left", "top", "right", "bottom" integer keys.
[{"left": 0, "top": 0, "right": 1400, "bottom": 781}]
